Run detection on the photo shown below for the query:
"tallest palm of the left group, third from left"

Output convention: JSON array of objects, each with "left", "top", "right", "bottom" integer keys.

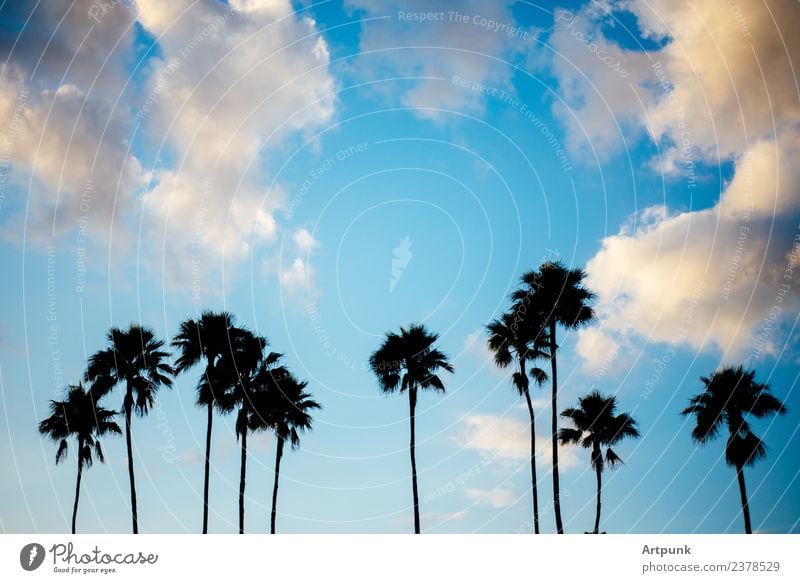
[{"left": 172, "top": 311, "right": 236, "bottom": 534}]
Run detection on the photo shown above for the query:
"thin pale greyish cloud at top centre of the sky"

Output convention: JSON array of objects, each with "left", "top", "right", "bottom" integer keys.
[{"left": 346, "top": 0, "right": 538, "bottom": 121}]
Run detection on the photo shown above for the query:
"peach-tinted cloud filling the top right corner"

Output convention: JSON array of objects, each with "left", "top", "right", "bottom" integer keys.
[{"left": 625, "top": 0, "right": 800, "bottom": 159}]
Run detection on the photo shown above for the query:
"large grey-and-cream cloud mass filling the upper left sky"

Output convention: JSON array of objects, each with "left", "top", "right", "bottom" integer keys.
[{"left": 0, "top": 0, "right": 335, "bottom": 301}]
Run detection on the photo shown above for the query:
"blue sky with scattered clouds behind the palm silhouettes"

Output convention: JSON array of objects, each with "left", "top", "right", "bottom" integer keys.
[{"left": 0, "top": 0, "right": 800, "bottom": 533}]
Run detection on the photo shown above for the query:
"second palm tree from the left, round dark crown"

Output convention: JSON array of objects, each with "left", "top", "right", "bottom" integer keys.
[{"left": 85, "top": 324, "right": 174, "bottom": 534}]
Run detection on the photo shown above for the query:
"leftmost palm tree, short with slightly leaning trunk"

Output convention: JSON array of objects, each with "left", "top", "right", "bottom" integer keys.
[{"left": 39, "top": 383, "right": 122, "bottom": 534}]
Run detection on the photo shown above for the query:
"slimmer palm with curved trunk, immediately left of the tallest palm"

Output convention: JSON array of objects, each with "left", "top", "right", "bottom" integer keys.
[{"left": 486, "top": 312, "right": 547, "bottom": 534}]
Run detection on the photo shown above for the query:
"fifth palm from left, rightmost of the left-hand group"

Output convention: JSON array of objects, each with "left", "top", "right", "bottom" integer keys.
[{"left": 250, "top": 369, "right": 321, "bottom": 534}]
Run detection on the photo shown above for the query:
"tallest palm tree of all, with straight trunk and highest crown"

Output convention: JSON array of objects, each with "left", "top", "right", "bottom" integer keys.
[{"left": 512, "top": 261, "right": 594, "bottom": 534}]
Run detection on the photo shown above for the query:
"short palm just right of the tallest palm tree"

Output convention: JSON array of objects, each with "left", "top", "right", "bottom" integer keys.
[{"left": 558, "top": 390, "right": 639, "bottom": 534}]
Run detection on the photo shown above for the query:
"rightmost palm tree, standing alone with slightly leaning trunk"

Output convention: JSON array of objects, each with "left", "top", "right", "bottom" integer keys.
[{"left": 681, "top": 366, "right": 786, "bottom": 534}]
